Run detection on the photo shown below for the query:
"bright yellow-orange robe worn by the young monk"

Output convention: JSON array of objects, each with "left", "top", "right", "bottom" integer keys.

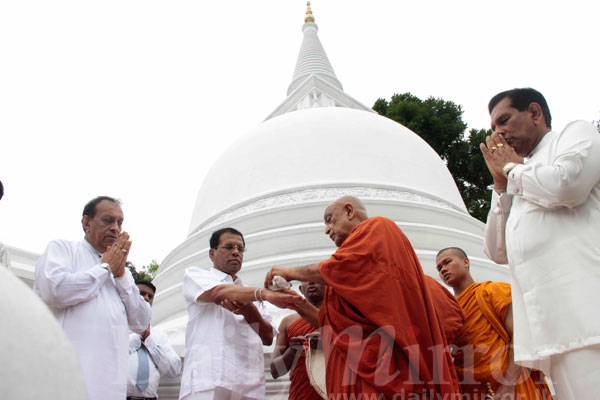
[{"left": 453, "top": 281, "right": 552, "bottom": 400}]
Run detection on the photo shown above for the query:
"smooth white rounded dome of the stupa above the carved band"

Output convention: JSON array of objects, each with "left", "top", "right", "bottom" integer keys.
[{"left": 190, "top": 107, "right": 466, "bottom": 233}]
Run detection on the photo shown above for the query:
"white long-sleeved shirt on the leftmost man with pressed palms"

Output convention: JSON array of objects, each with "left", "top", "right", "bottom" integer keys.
[{"left": 33, "top": 240, "right": 152, "bottom": 400}]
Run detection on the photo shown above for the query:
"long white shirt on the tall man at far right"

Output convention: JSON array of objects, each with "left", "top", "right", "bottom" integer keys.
[{"left": 485, "top": 121, "right": 600, "bottom": 367}]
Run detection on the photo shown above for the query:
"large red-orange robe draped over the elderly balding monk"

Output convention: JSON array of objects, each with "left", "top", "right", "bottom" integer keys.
[{"left": 319, "top": 217, "right": 460, "bottom": 400}]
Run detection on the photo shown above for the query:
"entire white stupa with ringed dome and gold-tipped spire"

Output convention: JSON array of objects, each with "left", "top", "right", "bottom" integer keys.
[{"left": 153, "top": 3, "right": 508, "bottom": 398}]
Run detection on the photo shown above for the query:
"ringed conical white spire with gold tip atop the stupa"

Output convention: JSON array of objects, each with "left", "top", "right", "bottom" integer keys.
[{"left": 288, "top": 1, "right": 343, "bottom": 95}]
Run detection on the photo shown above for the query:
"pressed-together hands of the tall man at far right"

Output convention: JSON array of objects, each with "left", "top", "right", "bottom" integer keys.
[{"left": 479, "top": 132, "right": 524, "bottom": 190}]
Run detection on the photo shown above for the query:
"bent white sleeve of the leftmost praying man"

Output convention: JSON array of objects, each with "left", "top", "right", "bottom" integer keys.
[{"left": 33, "top": 240, "right": 109, "bottom": 309}]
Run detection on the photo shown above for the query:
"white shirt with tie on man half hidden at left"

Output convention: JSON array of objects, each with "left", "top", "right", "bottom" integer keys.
[{"left": 127, "top": 328, "right": 181, "bottom": 397}]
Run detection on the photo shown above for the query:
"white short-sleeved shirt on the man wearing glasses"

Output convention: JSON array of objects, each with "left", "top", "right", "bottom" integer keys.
[{"left": 179, "top": 267, "right": 272, "bottom": 399}]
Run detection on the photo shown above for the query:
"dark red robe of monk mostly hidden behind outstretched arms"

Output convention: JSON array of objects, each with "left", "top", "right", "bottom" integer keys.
[{"left": 287, "top": 318, "right": 322, "bottom": 400}]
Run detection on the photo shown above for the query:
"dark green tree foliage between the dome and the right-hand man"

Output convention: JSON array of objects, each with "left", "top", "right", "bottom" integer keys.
[{"left": 373, "top": 93, "right": 493, "bottom": 221}]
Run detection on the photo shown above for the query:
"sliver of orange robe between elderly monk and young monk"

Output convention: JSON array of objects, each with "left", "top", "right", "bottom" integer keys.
[{"left": 425, "top": 275, "right": 465, "bottom": 344}]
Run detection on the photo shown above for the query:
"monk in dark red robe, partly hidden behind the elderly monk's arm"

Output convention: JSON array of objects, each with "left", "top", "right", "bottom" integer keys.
[{"left": 271, "top": 282, "right": 325, "bottom": 400}]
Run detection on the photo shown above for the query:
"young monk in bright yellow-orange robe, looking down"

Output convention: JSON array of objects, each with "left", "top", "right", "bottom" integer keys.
[{"left": 436, "top": 247, "right": 552, "bottom": 400}]
